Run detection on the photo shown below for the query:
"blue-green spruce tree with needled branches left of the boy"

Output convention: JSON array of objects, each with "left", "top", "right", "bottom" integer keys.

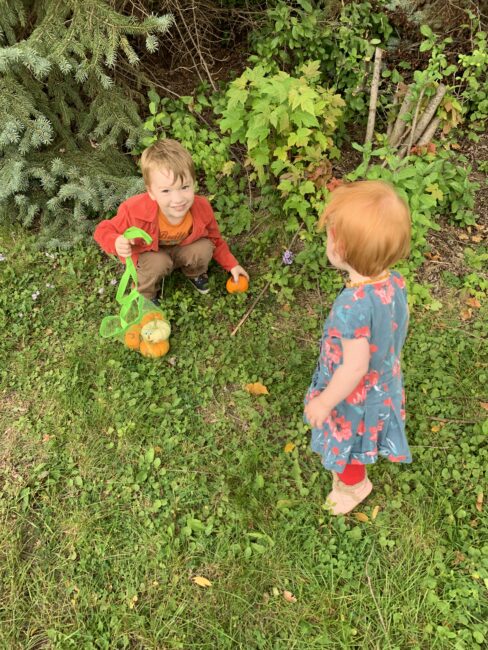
[{"left": 0, "top": 0, "right": 172, "bottom": 247}]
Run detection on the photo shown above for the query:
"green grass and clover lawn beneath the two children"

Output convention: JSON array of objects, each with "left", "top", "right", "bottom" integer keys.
[{"left": 0, "top": 227, "right": 488, "bottom": 650}]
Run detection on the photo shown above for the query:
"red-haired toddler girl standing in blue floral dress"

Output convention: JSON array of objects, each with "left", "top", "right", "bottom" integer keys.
[{"left": 305, "top": 181, "right": 412, "bottom": 515}]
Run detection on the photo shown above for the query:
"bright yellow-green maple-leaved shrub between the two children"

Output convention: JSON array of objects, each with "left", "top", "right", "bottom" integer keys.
[{"left": 220, "top": 61, "right": 344, "bottom": 232}]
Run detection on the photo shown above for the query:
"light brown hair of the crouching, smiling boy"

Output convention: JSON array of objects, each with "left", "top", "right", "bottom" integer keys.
[{"left": 141, "top": 138, "right": 196, "bottom": 187}]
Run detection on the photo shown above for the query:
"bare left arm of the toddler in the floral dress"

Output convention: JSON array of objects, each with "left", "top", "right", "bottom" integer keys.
[{"left": 305, "top": 337, "right": 369, "bottom": 428}]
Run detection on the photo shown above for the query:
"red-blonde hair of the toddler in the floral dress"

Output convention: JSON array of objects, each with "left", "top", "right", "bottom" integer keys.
[{"left": 319, "top": 181, "right": 410, "bottom": 277}]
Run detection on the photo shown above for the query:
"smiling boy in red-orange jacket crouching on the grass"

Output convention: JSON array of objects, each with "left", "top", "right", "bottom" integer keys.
[{"left": 94, "top": 140, "right": 249, "bottom": 302}]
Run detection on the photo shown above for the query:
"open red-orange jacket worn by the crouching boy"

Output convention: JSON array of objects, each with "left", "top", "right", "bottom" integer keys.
[{"left": 93, "top": 192, "right": 239, "bottom": 271}]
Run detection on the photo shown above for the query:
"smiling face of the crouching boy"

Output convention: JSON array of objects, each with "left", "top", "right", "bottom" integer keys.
[{"left": 146, "top": 168, "right": 195, "bottom": 226}]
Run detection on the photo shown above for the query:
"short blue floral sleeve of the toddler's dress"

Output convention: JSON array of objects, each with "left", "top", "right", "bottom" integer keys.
[{"left": 328, "top": 291, "right": 372, "bottom": 343}]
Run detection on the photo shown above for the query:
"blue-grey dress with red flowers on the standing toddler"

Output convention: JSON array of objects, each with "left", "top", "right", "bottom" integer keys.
[{"left": 305, "top": 271, "right": 412, "bottom": 473}]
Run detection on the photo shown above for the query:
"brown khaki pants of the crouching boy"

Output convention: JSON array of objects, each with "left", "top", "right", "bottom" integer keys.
[{"left": 137, "top": 238, "right": 214, "bottom": 299}]
